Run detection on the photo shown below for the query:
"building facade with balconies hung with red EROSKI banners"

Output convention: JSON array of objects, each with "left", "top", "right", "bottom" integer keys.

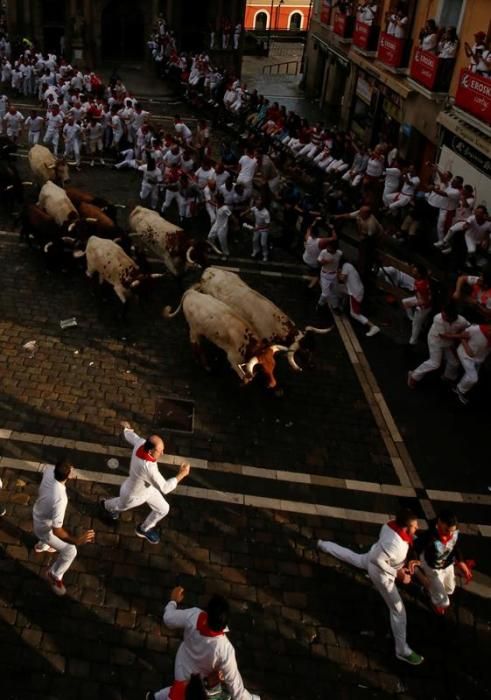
[{"left": 305, "top": 0, "right": 491, "bottom": 202}]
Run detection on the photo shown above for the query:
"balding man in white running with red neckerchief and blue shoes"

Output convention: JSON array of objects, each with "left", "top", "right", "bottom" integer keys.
[{"left": 100, "top": 421, "right": 190, "bottom": 544}]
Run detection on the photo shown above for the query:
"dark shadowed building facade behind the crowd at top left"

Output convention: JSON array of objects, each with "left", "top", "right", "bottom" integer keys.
[{"left": 7, "top": 0, "right": 245, "bottom": 66}]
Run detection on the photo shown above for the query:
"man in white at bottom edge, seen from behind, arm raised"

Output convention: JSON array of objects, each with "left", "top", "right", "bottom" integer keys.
[{"left": 146, "top": 586, "right": 260, "bottom": 700}]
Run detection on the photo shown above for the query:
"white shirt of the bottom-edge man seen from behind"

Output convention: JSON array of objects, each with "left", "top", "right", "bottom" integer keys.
[{"left": 164, "top": 600, "right": 253, "bottom": 700}]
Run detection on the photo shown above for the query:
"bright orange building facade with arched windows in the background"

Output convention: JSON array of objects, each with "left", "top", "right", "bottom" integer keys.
[{"left": 244, "top": 0, "right": 313, "bottom": 32}]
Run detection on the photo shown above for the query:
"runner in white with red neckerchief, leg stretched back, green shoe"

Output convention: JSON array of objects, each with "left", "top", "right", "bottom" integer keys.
[{"left": 317, "top": 508, "right": 424, "bottom": 666}]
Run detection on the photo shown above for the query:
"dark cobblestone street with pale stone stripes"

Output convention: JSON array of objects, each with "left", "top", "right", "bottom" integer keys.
[{"left": 0, "top": 86, "right": 491, "bottom": 700}]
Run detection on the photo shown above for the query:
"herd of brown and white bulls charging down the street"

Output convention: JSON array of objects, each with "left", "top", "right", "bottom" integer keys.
[{"left": 0, "top": 139, "right": 331, "bottom": 389}]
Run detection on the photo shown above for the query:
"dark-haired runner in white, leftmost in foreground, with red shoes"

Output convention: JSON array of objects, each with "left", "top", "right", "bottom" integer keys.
[{"left": 32, "top": 459, "right": 95, "bottom": 596}]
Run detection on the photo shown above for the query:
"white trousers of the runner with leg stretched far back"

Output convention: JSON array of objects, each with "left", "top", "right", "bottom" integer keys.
[{"left": 319, "top": 542, "right": 411, "bottom": 656}]
